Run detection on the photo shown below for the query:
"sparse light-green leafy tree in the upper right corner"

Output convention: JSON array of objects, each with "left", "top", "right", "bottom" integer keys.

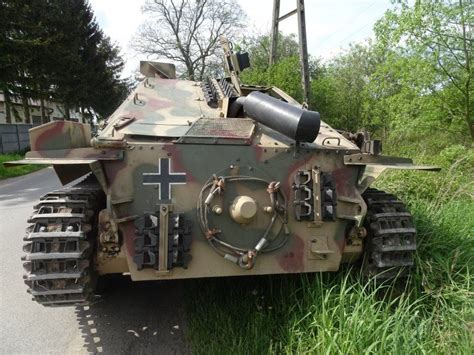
[{"left": 375, "top": 0, "right": 474, "bottom": 139}]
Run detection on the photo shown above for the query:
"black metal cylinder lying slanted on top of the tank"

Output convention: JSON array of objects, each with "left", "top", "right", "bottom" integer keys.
[{"left": 237, "top": 91, "right": 321, "bottom": 142}]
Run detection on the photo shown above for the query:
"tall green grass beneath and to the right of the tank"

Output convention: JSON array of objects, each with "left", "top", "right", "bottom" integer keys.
[{"left": 186, "top": 199, "right": 474, "bottom": 354}]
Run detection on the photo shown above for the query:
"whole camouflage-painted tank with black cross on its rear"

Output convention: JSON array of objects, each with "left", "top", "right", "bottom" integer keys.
[{"left": 7, "top": 39, "right": 436, "bottom": 306}]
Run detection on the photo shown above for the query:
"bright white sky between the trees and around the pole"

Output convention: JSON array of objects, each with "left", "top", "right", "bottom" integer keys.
[{"left": 89, "top": 0, "right": 391, "bottom": 75}]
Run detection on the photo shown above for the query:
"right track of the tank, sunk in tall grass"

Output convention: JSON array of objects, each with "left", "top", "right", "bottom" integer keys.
[{"left": 362, "top": 189, "right": 416, "bottom": 279}]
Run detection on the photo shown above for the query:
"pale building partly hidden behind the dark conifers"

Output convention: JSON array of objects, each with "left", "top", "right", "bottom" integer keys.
[{"left": 0, "top": 91, "right": 87, "bottom": 126}]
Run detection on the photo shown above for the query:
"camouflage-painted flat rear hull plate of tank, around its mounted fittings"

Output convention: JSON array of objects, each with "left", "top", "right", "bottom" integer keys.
[{"left": 98, "top": 143, "right": 365, "bottom": 280}]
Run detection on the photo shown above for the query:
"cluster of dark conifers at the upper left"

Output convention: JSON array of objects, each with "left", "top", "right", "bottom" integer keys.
[{"left": 0, "top": 0, "right": 129, "bottom": 123}]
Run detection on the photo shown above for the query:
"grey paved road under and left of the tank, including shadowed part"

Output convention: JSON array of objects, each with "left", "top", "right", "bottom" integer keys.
[{"left": 0, "top": 168, "right": 187, "bottom": 354}]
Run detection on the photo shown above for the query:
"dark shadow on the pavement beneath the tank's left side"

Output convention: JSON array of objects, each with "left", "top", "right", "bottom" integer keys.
[{"left": 76, "top": 276, "right": 189, "bottom": 354}]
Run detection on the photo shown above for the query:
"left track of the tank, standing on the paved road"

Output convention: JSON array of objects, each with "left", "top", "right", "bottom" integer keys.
[{"left": 22, "top": 175, "right": 104, "bottom": 306}]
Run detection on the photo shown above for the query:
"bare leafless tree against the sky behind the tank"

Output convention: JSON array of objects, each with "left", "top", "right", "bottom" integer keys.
[{"left": 132, "top": 0, "right": 245, "bottom": 80}]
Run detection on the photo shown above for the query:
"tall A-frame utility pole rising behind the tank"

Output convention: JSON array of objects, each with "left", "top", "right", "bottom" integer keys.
[{"left": 270, "top": 0, "right": 309, "bottom": 103}]
